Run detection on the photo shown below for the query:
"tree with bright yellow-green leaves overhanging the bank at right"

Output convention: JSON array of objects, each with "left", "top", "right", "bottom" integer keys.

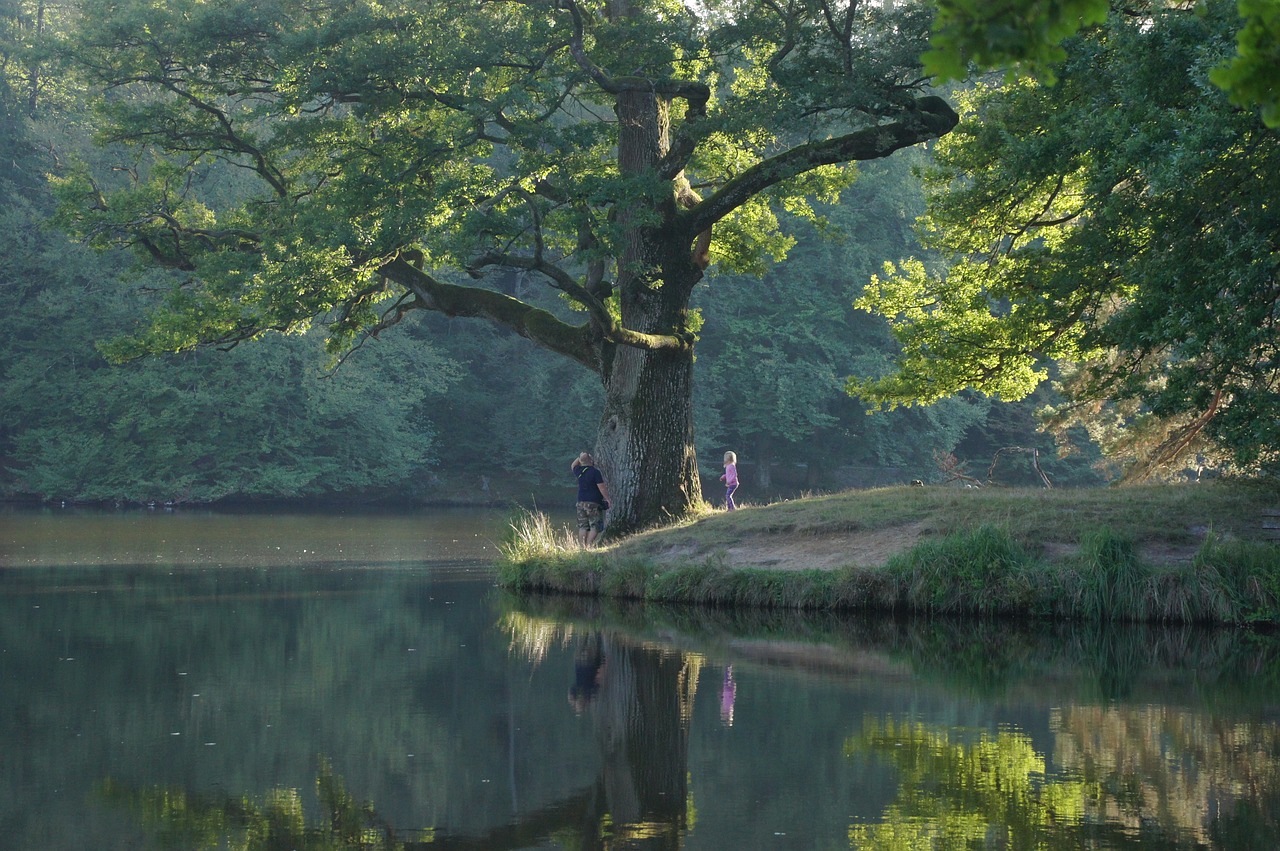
[{"left": 852, "top": 0, "right": 1280, "bottom": 477}]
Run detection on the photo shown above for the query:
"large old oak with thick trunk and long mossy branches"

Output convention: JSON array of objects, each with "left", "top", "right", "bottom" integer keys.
[{"left": 55, "top": 0, "right": 957, "bottom": 530}]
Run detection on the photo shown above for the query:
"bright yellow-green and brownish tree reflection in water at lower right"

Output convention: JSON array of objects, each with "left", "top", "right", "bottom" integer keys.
[{"left": 845, "top": 708, "right": 1280, "bottom": 851}]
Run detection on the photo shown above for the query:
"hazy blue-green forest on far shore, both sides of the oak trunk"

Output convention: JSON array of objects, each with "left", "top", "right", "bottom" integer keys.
[{"left": 0, "top": 3, "right": 1269, "bottom": 503}]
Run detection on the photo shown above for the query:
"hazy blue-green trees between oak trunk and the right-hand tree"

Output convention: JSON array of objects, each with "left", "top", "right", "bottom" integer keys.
[{"left": 695, "top": 152, "right": 989, "bottom": 497}]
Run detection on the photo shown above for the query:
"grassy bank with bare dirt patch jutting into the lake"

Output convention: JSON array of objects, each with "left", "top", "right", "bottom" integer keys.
[{"left": 499, "top": 482, "right": 1280, "bottom": 624}]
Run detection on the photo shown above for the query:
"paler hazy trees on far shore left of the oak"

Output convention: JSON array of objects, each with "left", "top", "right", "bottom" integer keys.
[{"left": 0, "top": 3, "right": 457, "bottom": 503}]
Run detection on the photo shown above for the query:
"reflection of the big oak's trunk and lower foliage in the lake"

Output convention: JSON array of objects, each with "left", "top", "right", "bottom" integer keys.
[{"left": 102, "top": 623, "right": 701, "bottom": 851}]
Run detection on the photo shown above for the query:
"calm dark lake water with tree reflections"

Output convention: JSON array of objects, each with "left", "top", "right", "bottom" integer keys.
[{"left": 0, "top": 511, "right": 1280, "bottom": 851}]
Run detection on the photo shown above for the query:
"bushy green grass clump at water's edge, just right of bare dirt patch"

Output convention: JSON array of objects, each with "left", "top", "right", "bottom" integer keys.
[{"left": 886, "top": 525, "right": 1036, "bottom": 616}]
